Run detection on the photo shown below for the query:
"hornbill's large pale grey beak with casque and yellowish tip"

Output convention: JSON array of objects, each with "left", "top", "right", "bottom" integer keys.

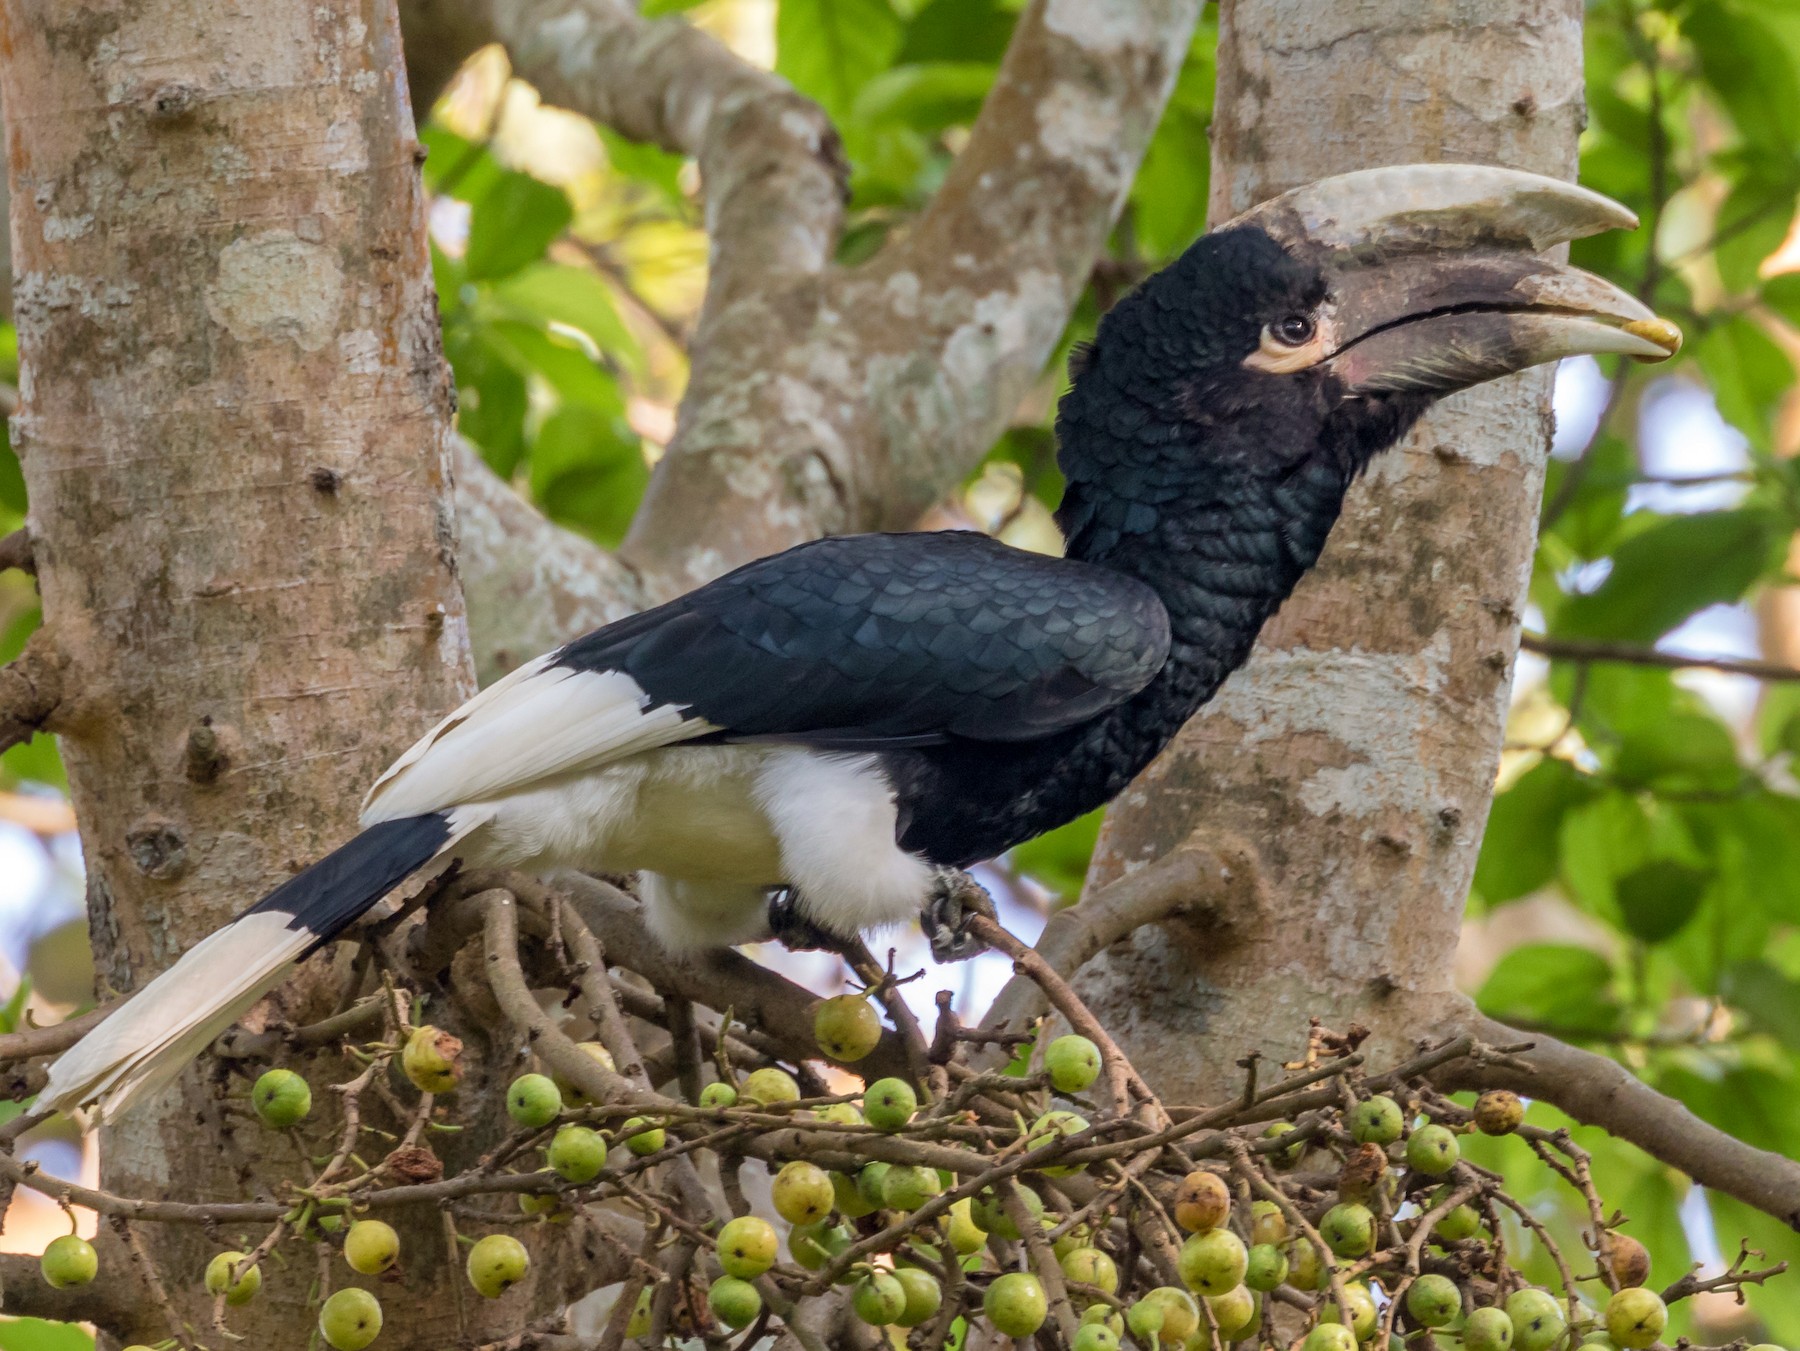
[{"left": 1231, "top": 164, "right": 1681, "bottom": 394}]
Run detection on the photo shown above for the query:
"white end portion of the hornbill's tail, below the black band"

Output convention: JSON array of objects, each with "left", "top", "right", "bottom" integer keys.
[{"left": 38, "top": 910, "right": 317, "bottom": 1117}]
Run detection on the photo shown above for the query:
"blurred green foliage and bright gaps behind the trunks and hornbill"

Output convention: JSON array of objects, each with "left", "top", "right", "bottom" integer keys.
[{"left": 0, "top": 0, "right": 1800, "bottom": 1351}]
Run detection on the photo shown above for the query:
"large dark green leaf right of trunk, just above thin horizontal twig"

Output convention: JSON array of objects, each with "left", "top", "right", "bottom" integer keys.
[{"left": 1552, "top": 507, "right": 1782, "bottom": 642}]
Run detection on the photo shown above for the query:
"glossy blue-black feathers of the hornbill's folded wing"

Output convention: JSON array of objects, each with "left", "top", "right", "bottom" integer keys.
[{"left": 556, "top": 531, "right": 1168, "bottom": 750}]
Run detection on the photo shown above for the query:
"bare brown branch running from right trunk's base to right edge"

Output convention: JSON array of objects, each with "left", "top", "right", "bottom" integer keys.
[{"left": 1433, "top": 1009, "right": 1800, "bottom": 1229}]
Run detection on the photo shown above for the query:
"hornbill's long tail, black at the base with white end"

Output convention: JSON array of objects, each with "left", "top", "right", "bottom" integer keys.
[{"left": 38, "top": 810, "right": 482, "bottom": 1117}]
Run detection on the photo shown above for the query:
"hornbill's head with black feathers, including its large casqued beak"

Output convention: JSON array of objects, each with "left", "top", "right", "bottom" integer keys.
[{"left": 1060, "top": 164, "right": 1681, "bottom": 510}]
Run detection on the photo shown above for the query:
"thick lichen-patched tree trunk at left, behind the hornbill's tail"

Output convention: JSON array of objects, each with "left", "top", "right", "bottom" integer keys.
[{"left": 0, "top": 0, "right": 473, "bottom": 1346}]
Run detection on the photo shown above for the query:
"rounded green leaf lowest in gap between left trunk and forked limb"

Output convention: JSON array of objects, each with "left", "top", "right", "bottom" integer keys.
[{"left": 531, "top": 405, "right": 650, "bottom": 547}]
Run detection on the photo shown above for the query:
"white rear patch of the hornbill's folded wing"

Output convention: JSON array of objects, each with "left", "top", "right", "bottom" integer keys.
[{"left": 362, "top": 653, "right": 718, "bottom": 826}]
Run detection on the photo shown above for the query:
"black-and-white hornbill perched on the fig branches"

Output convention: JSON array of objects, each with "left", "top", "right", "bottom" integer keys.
[{"left": 40, "top": 166, "right": 1679, "bottom": 1114}]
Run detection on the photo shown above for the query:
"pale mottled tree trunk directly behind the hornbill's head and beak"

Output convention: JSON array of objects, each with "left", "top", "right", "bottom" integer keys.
[{"left": 1080, "top": 0, "right": 1584, "bottom": 1103}]
